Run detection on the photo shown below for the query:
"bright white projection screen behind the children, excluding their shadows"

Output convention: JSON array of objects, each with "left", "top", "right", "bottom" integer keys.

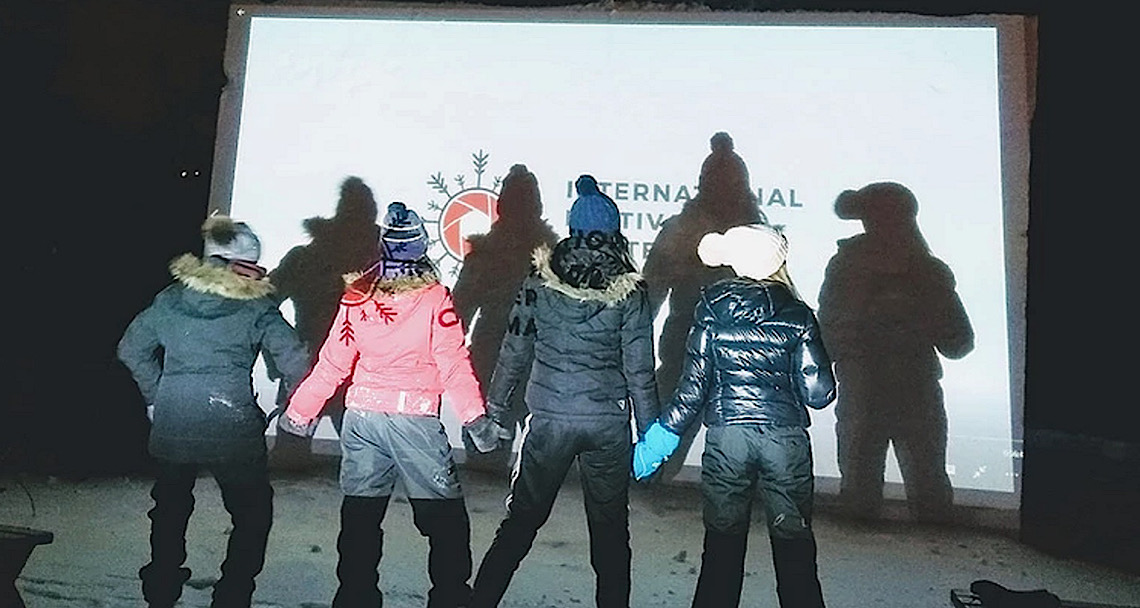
[{"left": 211, "top": 5, "right": 1028, "bottom": 502}]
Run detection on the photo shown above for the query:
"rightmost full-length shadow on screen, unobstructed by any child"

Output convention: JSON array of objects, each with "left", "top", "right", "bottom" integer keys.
[{"left": 819, "top": 183, "right": 974, "bottom": 521}]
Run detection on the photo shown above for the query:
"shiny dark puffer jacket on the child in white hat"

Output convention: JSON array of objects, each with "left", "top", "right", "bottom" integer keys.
[{"left": 661, "top": 277, "right": 836, "bottom": 435}]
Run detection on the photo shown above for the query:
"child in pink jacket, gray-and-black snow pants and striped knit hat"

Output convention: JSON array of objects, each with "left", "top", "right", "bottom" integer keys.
[{"left": 278, "top": 203, "right": 505, "bottom": 608}]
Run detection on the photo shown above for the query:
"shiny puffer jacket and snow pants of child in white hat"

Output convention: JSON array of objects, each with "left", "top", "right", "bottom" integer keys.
[{"left": 660, "top": 277, "right": 836, "bottom": 608}]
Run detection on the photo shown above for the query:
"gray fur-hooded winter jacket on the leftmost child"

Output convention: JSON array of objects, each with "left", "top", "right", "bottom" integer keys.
[{"left": 119, "top": 254, "right": 309, "bottom": 463}]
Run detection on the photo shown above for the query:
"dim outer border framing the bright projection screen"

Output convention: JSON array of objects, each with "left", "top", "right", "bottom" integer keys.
[{"left": 207, "top": 1, "right": 1036, "bottom": 509}]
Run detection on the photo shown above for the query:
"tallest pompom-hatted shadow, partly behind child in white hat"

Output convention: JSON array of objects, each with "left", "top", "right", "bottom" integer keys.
[{"left": 642, "top": 132, "right": 767, "bottom": 480}]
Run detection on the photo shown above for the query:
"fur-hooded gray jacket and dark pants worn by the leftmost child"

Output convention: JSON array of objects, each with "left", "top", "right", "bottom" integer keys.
[{"left": 119, "top": 254, "right": 309, "bottom": 607}]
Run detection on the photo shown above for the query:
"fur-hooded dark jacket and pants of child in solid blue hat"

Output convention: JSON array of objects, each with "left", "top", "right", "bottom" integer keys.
[{"left": 471, "top": 236, "right": 658, "bottom": 608}]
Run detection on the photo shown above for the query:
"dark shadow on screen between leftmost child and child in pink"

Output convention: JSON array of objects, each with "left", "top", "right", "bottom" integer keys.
[{"left": 269, "top": 177, "right": 380, "bottom": 468}]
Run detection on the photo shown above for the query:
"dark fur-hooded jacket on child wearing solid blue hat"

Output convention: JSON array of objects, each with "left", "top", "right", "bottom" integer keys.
[{"left": 487, "top": 237, "right": 658, "bottom": 431}]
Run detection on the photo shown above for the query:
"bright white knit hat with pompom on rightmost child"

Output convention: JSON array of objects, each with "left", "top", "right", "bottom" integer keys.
[{"left": 697, "top": 224, "right": 788, "bottom": 279}]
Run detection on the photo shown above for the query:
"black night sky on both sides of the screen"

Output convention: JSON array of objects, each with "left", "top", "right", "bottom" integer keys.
[{"left": 0, "top": 0, "right": 1138, "bottom": 470}]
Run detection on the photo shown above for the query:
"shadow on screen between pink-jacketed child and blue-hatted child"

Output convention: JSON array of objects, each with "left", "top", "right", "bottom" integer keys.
[{"left": 451, "top": 164, "right": 559, "bottom": 472}]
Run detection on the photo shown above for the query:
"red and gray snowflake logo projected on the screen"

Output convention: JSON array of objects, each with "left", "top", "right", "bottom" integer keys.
[{"left": 424, "top": 151, "right": 503, "bottom": 278}]
